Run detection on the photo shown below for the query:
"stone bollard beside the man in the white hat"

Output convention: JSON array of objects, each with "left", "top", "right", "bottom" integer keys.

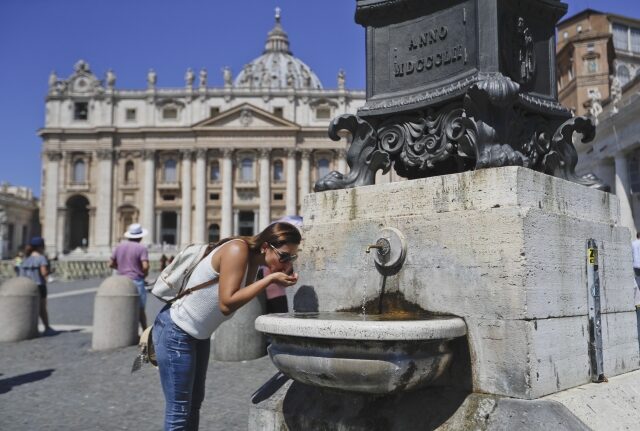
[{"left": 91, "top": 275, "right": 140, "bottom": 350}]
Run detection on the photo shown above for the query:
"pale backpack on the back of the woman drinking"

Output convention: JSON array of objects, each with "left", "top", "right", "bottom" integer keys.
[{"left": 151, "top": 244, "right": 216, "bottom": 303}]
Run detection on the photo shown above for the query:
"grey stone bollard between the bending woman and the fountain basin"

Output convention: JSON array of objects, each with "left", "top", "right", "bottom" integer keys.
[{"left": 213, "top": 295, "right": 267, "bottom": 361}]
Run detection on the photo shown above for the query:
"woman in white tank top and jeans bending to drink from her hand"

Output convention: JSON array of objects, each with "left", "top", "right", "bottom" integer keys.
[{"left": 151, "top": 223, "right": 302, "bottom": 430}]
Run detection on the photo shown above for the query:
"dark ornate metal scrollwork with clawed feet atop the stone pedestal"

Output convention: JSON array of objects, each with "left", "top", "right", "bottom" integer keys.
[{"left": 315, "top": 73, "right": 608, "bottom": 191}]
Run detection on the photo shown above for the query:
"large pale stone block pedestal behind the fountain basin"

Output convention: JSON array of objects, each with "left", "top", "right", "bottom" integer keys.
[{"left": 289, "top": 167, "right": 639, "bottom": 399}]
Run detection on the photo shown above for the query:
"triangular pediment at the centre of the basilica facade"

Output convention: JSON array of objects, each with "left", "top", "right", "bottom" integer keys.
[{"left": 193, "top": 103, "right": 300, "bottom": 130}]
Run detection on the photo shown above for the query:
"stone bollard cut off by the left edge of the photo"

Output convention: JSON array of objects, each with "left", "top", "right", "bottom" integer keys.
[{"left": 0, "top": 277, "right": 40, "bottom": 341}]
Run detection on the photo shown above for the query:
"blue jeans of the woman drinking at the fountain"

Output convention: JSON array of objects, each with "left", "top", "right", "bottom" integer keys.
[{"left": 152, "top": 305, "right": 211, "bottom": 430}]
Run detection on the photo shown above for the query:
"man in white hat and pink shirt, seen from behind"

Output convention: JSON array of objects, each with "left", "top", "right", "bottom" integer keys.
[{"left": 110, "top": 223, "right": 149, "bottom": 331}]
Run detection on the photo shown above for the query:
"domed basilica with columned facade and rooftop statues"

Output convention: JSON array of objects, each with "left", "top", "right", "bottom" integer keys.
[{"left": 39, "top": 12, "right": 365, "bottom": 256}]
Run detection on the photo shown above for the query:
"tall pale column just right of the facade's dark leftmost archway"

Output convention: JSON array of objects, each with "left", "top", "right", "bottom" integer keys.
[{"left": 94, "top": 149, "right": 113, "bottom": 254}]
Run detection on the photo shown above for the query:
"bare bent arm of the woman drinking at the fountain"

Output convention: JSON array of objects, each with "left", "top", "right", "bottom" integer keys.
[{"left": 219, "top": 241, "right": 298, "bottom": 316}]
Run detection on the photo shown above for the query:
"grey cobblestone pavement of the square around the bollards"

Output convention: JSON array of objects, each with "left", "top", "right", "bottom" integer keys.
[{"left": 0, "top": 280, "right": 276, "bottom": 431}]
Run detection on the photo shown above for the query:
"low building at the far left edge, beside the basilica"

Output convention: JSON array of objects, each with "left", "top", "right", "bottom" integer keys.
[{"left": 0, "top": 183, "right": 40, "bottom": 259}]
